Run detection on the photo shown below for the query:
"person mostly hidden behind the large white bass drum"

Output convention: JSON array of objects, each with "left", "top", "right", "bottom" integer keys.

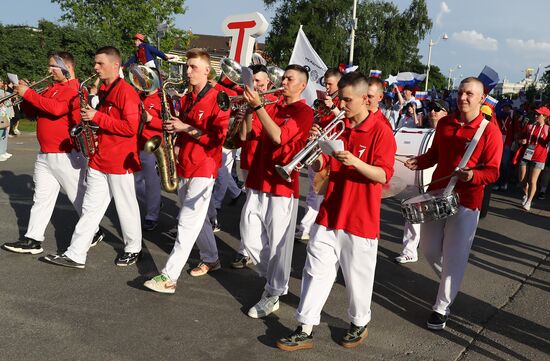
[{"left": 395, "top": 99, "right": 449, "bottom": 263}]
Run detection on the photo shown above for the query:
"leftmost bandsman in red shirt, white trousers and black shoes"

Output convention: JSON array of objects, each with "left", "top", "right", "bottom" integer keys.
[{"left": 4, "top": 52, "right": 103, "bottom": 254}]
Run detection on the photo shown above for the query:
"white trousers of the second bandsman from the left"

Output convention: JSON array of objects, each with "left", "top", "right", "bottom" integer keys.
[{"left": 65, "top": 168, "right": 141, "bottom": 263}]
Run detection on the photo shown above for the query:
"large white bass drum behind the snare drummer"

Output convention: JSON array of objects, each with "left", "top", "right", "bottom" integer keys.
[{"left": 394, "top": 128, "right": 435, "bottom": 195}]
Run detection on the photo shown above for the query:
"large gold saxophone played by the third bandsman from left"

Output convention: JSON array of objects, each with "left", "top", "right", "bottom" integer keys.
[{"left": 143, "top": 80, "right": 184, "bottom": 193}]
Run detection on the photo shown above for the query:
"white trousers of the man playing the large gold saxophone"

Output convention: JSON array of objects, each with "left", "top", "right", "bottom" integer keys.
[{"left": 162, "top": 178, "right": 218, "bottom": 282}]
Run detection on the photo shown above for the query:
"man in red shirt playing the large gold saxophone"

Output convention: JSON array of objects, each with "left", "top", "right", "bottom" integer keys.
[{"left": 144, "top": 49, "right": 229, "bottom": 293}]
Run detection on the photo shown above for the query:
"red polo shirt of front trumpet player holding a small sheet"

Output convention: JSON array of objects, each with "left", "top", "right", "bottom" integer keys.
[{"left": 316, "top": 110, "right": 397, "bottom": 238}]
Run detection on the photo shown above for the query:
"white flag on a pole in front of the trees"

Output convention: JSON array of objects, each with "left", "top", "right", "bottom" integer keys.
[{"left": 288, "top": 26, "right": 327, "bottom": 106}]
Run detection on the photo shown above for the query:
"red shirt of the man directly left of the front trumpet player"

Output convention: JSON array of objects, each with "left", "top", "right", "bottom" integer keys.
[{"left": 246, "top": 99, "right": 313, "bottom": 198}]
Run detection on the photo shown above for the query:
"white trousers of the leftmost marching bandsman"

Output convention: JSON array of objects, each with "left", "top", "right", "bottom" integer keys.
[{"left": 25, "top": 150, "right": 87, "bottom": 242}]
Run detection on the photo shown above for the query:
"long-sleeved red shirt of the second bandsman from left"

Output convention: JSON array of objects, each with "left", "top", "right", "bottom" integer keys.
[{"left": 89, "top": 79, "right": 141, "bottom": 174}]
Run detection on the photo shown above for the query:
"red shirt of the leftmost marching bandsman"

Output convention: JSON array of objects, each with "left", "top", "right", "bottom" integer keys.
[{"left": 22, "top": 79, "right": 80, "bottom": 153}]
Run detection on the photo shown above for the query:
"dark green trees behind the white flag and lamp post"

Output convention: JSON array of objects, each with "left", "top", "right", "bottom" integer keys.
[{"left": 264, "top": 0, "right": 446, "bottom": 87}]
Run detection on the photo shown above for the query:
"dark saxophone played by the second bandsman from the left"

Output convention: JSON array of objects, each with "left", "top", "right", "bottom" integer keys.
[{"left": 69, "top": 73, "right": 98, "bottom": 159}]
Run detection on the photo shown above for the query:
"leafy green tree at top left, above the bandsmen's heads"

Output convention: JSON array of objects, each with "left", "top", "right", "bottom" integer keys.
[{"left": 51, "top": 0, "right": 191, "bottom": 58}]
